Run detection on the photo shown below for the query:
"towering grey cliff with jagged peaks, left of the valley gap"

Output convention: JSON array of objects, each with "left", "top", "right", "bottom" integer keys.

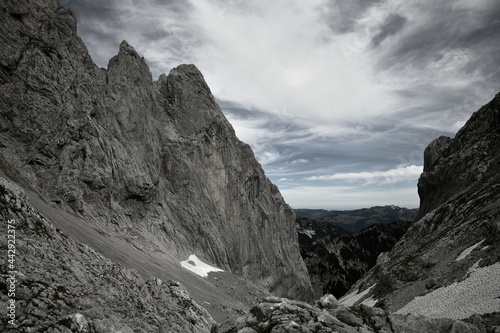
[{"left": 0, "top": 0, "right": 312, "bottom": 300}]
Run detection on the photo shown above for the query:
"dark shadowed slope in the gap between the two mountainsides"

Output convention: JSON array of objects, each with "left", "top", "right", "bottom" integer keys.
[{"left": 300, "top": 221, "right": 411, "bottom": 298}]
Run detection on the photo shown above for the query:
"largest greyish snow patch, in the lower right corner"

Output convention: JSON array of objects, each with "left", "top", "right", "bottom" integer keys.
[{"left": 396, "top": 262, "right": 500, "bottom": 319}]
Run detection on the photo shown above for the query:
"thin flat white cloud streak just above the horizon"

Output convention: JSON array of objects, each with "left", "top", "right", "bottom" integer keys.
[{"left": 306, "top": 165, "right": 423, "bottom": 185}]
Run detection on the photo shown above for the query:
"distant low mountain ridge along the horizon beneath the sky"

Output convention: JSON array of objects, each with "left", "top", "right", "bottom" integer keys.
[{"left": 294, "top": 206, "right": 418, "bottom": 232}]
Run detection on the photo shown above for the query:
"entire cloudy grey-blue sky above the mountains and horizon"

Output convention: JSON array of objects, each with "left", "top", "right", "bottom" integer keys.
[{"left": 60, "top": 0, "right": 500, "bottom": 209}]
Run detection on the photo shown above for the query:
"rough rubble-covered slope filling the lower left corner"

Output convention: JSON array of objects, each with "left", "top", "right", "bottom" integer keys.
[{"left": 0, "top": 177, "right": 215, "bottom": 333}]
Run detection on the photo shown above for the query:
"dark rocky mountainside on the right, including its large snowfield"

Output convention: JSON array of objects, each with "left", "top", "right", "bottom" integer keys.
[{"left": 340, "top": 94, "right": 500, "bottom": 325}]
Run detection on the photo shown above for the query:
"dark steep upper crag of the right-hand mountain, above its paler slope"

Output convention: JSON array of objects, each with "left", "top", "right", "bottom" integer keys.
[{"left": 418, "top": 95, "right": 500, "bottom": 218}]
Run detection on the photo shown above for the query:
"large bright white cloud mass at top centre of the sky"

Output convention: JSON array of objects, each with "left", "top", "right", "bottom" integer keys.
[{"left": 188, "top": 0, "right": 393, "bottom": 123}]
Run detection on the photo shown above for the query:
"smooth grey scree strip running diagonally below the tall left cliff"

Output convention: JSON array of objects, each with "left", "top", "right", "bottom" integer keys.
[{"left": 18, "top": 172, "right": 253, "bottom": 321}]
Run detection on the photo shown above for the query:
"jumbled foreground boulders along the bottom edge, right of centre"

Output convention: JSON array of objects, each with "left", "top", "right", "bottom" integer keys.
[{"left": 211, "top": 295, "right": 480, "bottom": 333}]
